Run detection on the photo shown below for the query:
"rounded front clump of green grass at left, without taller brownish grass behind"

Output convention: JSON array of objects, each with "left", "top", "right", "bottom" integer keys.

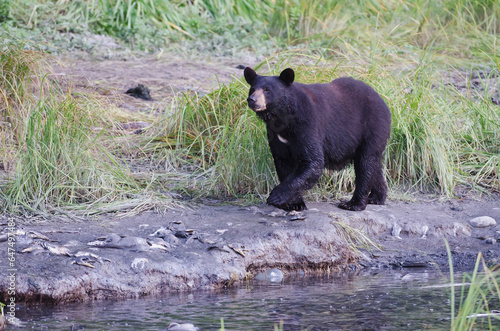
[{"left": 2, "top": 91, "right": 130, "bottom": 210}]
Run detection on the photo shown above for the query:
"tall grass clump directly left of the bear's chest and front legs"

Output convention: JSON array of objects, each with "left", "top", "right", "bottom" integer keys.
[{"left": 148, "top": 81, "right": 275, "bottom": 197}]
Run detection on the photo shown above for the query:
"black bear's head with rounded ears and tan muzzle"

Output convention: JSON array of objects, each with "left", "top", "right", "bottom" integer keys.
[{"left": 244, "top": 67, "right": 295, "bottom": 118}]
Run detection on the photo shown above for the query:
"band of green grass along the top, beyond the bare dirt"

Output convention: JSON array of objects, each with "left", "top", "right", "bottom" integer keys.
[{"left": 0, "top": 0, "right": 500, "bottom": 60}]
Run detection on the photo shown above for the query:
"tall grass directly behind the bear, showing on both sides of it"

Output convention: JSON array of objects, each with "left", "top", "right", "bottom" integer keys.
[{"left": 147, "top": 45, "right": 500, "bottom": 200}]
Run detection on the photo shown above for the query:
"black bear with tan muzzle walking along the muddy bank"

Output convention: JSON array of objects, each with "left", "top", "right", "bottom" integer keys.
[{"left": 244, "top": 67, "right": 391, "bottom": 211}]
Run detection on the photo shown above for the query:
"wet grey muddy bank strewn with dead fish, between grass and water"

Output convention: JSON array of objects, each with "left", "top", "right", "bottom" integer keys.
[{"left": 0, "top": 197, "right": 500, "bottom": 303}]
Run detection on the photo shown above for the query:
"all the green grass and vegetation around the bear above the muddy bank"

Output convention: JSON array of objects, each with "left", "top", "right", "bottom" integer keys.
[{"left": 0, "top": 0, "right": 500, "bottom": 210}]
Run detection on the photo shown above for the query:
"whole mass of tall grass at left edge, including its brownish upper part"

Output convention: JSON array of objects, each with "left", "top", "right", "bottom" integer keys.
[{"left": 0, "top": 45, "right": 143, "bottom": 212}]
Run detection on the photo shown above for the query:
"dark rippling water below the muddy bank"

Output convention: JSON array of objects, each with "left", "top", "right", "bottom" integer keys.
[{"left": 9, "top": 270, "right": 490, "bottom": 331}]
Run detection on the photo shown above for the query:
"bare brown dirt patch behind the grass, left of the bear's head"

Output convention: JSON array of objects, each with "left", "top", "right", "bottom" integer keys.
[{"left": 54, "top": 54, "right": 250, "bottom": 113}]
